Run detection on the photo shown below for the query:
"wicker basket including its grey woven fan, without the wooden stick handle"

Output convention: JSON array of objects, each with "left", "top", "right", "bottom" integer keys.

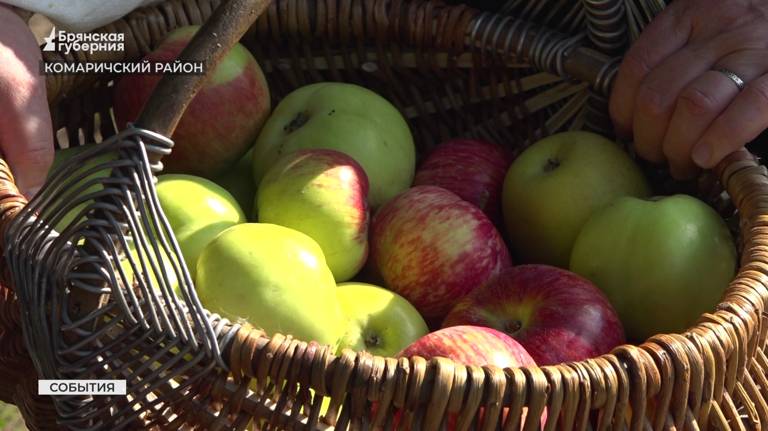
[{"left": 0, "top": 0, "right": 768, "bottom": 430}]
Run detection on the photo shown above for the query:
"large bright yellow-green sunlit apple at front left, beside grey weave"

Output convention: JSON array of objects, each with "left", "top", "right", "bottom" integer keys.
[{"left": 196, "top": 223, "right": 346, "bottom": 348}]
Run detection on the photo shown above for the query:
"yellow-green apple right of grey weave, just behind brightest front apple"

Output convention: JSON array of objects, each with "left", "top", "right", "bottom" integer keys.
[{"left": 157, "top": 174, "right": 246, "bottom": 279}]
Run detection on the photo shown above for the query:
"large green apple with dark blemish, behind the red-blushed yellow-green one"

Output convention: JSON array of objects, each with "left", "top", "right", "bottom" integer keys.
[{"left": 253, "top": 82, "right": 416, "bottom": 208}]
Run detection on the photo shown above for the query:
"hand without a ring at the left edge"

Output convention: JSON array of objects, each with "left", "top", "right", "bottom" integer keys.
[{"left": 0, "top": 5, "right": 53, "bottom": 198}]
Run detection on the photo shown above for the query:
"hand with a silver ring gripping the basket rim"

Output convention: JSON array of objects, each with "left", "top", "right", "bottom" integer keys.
[{"left": 610, "top": 0, "right": 768, "bottom": 179}]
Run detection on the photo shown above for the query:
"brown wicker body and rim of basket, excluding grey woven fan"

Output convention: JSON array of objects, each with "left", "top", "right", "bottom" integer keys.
[{"left": 0, "top": 0, "right": 768, "bottom": 431}]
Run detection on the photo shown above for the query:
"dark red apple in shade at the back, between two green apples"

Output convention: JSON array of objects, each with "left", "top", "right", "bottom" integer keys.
[{"left": 413, "top": 139, "right": 512, "bottom": 223}]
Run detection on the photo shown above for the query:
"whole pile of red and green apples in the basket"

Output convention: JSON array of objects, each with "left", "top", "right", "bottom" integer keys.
[{"left": 52, "top": 28, "right": 736, "bottom": 380}]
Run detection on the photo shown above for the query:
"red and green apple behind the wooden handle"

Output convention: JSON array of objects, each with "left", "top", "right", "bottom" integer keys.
[{"left": 115, "top": 26, "right": 270, "bottom": 178}]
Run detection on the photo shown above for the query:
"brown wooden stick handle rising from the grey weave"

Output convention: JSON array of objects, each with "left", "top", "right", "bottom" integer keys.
[{"left": 136, "top": 0, "right": 270, "bottom": 143}]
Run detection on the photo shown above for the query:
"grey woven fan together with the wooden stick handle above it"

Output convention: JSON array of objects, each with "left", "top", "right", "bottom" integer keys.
[{"left": 0, "top": 0, "right": 269, "bottom": 429}]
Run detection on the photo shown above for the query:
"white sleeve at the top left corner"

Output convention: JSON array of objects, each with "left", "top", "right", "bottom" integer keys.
[{"left": 0, "top": 0, "right": 158, "bottom": 32}]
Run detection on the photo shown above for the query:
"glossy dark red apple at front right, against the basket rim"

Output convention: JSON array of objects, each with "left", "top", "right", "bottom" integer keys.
[{"left": 443, "top": 265, "right": 624, "bottom": 365}]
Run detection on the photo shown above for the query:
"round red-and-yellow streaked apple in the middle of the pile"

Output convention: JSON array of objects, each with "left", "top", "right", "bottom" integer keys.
[{"left": 371, "top": 186, "right": 512, "bottom": 321}]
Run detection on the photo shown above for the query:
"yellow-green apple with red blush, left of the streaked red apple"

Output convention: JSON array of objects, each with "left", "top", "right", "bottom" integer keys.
[{"left": 254, "top": 149, "right": 368, "bottom": 282}]
